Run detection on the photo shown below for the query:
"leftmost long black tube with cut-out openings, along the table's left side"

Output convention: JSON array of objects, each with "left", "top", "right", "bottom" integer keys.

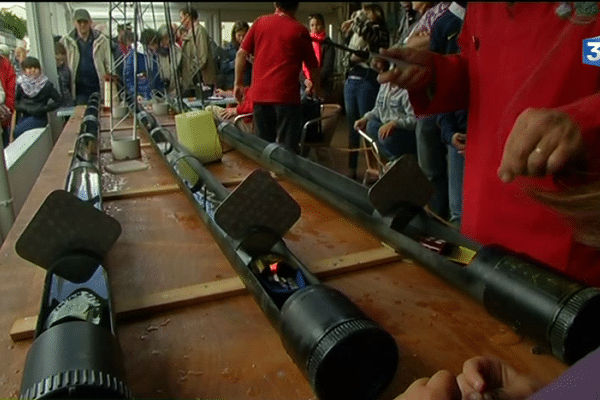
[{"left": 17, "top": 93, "right": 131, "bottom": 399}]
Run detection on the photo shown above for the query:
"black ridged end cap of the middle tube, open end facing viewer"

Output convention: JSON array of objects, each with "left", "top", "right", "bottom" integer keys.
[{"left": 280, "top": 285, "right": 399, "bottom": 400}]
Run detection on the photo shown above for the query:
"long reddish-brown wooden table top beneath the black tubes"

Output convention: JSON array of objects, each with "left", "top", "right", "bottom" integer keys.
[{"left": 0, "top": 107, "right": 566, "bottom": 400}]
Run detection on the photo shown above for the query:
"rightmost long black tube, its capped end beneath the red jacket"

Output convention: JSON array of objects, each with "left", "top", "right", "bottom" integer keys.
[{"left": 219, "top": 123, "right": 600, "bottom": 363}]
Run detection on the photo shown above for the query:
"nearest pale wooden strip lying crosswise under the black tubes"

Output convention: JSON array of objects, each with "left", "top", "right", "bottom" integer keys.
[{"left": 10, "top": 247, "right": 402, "bottom": 341}]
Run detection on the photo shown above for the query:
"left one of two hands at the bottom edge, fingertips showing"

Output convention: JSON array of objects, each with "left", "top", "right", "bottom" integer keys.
[{"left": 395, "top": 371, "right": 461, "bottom": 400}]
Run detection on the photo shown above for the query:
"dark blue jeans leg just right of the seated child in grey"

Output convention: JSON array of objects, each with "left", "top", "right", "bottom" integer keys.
[{"left": 416, "top": 116, "right": 448, "bottom": 218}]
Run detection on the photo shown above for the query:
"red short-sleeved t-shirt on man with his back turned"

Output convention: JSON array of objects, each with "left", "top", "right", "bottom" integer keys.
[{"left": 241, "top": 13, "right": 318, "bottom": 104}]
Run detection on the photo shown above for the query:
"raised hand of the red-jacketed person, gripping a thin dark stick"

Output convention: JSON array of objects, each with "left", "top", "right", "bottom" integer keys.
[{"left": 377, "top": 48, "right": 435, "bottom": 90}]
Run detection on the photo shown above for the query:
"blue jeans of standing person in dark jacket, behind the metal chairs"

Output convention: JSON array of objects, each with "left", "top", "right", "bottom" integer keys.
[{"left": 344, "top": 75, "right": 379, "bottom": 170}]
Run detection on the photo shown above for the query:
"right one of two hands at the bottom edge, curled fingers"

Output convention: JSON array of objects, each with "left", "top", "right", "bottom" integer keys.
[{"left": 456, "top": 356, "right": 544, "bottom": 400}]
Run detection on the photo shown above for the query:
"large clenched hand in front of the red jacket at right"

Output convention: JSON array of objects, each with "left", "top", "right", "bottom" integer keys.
[{"left": 498, "top": 108, "right": 584, "bottom": 183}]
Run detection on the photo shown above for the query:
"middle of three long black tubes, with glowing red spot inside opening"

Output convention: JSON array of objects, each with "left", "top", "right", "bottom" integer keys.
[{"left": 134, "top": 100, "right": 399, "bottom": 400}]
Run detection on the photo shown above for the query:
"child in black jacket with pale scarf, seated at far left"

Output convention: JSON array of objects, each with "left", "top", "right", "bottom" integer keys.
[{"left": 14, "top": 57, "right": 62, "bottom": 139}]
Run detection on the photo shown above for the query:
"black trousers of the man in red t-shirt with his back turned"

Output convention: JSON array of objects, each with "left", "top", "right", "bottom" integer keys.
[{"left": 253, "top": 104, "right": 302, "bottom": 153}]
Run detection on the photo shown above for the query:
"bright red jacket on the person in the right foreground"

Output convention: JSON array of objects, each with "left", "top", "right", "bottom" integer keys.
[{"left": 410, "top": 3, "right": 600, "bottom": 286}]
